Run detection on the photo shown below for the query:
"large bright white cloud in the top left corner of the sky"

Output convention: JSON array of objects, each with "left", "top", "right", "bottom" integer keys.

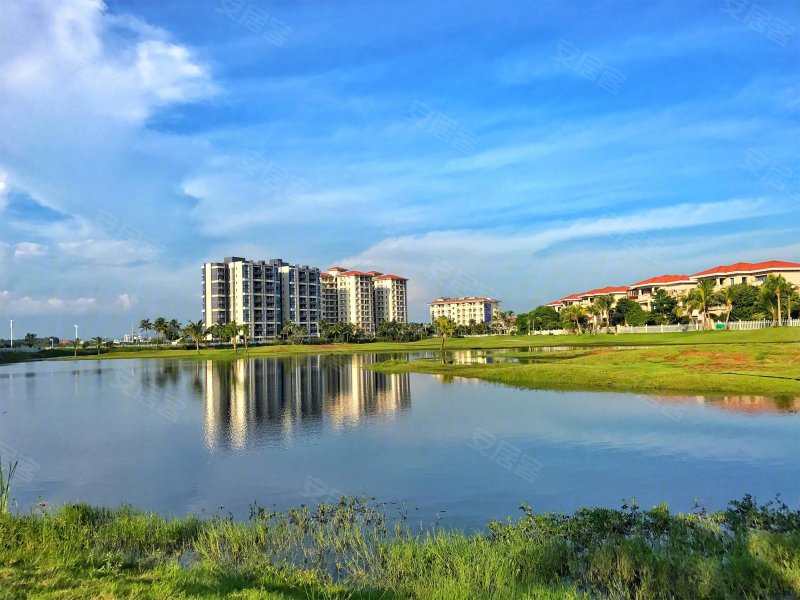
[{"left": 0, "top": 0, "right": 215, "bottom": 121}]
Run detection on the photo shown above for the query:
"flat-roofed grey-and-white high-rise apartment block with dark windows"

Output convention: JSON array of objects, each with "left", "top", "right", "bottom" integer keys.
[{"left": 203, "top": 256, "right": 320, "bottom": 341}]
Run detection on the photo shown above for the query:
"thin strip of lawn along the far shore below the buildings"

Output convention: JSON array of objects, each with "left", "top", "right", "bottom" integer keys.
[{"left": 0, "top": 327, "right": 800, "bottom": 364}]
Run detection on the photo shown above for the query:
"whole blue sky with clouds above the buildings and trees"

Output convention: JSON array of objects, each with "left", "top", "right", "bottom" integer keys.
[{"left": 0, "top": 0, "right": 800, "bottom": 337}]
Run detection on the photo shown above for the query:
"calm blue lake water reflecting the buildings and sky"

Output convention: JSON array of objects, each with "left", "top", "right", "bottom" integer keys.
[{"left": 0, "top": 352, "right": 800, "bottom": 528}]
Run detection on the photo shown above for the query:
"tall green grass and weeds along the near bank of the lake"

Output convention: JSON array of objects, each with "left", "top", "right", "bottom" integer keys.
[{"left": 0, "top": 497, "right": 800, "bottom": 599}]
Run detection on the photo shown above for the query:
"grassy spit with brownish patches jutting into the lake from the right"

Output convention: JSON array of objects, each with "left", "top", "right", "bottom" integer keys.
[{"left": 371, "top": 343, "right": 800, "bottom": 397}]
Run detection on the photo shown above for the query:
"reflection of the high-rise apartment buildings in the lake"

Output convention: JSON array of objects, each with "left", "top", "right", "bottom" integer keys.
[{"left": 204, "top": 355, "right": 411, "bottom": 448}]
